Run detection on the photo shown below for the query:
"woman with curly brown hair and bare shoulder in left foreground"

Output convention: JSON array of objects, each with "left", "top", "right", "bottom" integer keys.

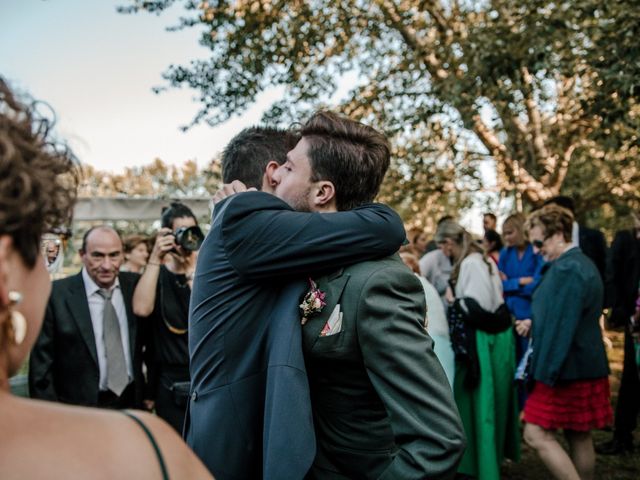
[{"left": 0, "top": 78, "right": 211, "bottom": 479}]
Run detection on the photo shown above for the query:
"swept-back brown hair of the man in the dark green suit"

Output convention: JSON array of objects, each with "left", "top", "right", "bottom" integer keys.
[{"left": 300, "top": 111, "right": 391, "bottom": 210}]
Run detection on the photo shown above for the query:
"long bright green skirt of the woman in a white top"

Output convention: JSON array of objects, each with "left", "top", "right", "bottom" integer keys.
[{"left": 453, "top": 328, "right": 520, "bottom": 480}]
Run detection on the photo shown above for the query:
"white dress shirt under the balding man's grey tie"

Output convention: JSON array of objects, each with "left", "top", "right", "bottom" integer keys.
[{"left": 82, "top": 268, "right": 133, "bottom": 392}]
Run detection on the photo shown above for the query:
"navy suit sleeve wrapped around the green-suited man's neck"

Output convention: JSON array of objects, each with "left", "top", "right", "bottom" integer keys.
[{"left": 214, "top": 192, "right": 405, "bottom": 280}]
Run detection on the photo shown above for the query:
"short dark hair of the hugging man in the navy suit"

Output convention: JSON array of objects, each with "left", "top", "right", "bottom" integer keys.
[{"left": 222, "top": 127, "right": 299, "bottom": 190}]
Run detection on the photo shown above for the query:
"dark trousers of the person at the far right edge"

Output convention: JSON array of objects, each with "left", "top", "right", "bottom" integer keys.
[{"left": 615, "top": 328, "right": 640, "bottom": 442}]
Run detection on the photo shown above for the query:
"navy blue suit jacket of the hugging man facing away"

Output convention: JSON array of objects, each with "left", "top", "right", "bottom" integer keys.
[{"left": 185, "top": 192, "right": 405, "bottom": 480}]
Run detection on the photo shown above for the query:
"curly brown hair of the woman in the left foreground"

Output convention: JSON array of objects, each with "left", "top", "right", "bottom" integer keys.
[{"left": 0, "top": 77, "right": 78, "bottom": 268}]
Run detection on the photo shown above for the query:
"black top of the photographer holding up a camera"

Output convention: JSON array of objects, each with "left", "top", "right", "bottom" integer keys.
[{"left": 146, "top": 265, "right": 191, "bottom": 390}]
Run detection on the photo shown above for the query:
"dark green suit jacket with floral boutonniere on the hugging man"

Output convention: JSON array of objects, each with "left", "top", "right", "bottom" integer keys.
[{"left": 302, "top": 255, "right": 464, "bottom": 479}]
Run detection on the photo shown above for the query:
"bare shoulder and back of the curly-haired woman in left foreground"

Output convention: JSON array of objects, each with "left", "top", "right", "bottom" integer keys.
[{"left": 0, "top": 399, "right": 212, "bottom": 480}]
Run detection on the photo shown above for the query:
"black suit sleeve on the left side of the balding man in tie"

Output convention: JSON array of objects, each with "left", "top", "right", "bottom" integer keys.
[{"left": 29, "top": 300, "right": 58, "bottom": 401}]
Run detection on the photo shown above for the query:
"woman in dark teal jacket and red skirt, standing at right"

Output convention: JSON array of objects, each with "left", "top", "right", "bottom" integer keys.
[{"left": 524, "top": 205, "right": 612, "bottom": 480}]
